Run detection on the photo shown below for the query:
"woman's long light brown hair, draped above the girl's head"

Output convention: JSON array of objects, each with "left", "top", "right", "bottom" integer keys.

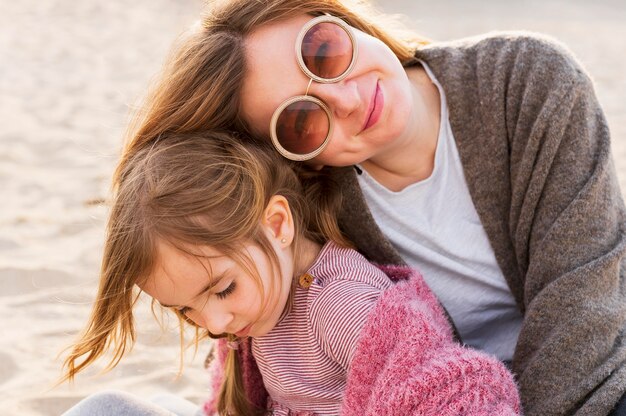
[{"left": 114, "top": 0, "right": 427, "bottom": 187}]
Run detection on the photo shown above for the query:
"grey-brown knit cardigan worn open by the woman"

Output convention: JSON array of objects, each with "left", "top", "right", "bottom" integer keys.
[{"left": 333, "top": 33, "right": 626, "bottom": 416}]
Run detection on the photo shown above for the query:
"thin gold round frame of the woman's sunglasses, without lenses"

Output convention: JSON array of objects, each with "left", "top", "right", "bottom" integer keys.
[{"left": 270, "top": 14, "right": 358, "bottom": 162}]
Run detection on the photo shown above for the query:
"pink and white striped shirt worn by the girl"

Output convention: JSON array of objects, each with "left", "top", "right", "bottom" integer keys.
[{"left": 252, "top": 242, "right": 392, "bottom": 415}]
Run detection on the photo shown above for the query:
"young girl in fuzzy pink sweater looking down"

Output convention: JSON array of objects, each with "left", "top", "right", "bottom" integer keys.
[{"left": 66, "top": 133, "right": 519, "bottom": 415}]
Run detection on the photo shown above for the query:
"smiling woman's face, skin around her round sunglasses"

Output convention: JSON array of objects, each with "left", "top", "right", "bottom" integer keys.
[{"left": 241, "top": 15, "right": 413, "bottom": 166}]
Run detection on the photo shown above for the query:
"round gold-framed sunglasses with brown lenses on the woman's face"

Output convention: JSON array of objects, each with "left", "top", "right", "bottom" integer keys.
[{"left": 270, "top": 15, "right": 357, "bottom": 161}]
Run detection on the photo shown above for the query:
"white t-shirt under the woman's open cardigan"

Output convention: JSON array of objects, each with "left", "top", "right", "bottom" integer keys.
[{"left": 358, "top": 62, "right": 523, "bottom": 361}]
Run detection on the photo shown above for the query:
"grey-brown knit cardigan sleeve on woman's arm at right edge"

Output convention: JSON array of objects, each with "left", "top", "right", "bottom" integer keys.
[{"left": 498, "top": 39, "right": 626, "bottom": 415}]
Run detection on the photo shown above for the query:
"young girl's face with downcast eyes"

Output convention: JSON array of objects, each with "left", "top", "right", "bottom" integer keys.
[{"left": 141, "top": 236, "right": 293, "bottom": 337}]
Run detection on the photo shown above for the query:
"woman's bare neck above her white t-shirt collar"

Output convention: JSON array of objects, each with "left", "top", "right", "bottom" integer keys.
[{"left": 361, "top": 66, "right": 441, "bottom": 192}]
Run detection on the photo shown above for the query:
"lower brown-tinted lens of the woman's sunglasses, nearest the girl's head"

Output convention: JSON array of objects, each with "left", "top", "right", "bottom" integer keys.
[{"left": 276, "top": 100, "right": 330, "bottom": 155}]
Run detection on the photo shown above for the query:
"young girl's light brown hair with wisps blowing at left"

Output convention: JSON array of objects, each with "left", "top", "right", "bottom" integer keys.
[{"left": 65, "top": 131, "right": 348, "bottom": 415}]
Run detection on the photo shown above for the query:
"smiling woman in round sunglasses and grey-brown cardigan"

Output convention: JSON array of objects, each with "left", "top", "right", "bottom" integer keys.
[{"left": 113, "top": 0, "right": 626, "bottom": 415}]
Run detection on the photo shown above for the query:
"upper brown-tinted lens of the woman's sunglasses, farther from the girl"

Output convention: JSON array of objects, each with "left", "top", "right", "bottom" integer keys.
[{"left": 301, "top": 22, "right": 353, "bottom": 79}]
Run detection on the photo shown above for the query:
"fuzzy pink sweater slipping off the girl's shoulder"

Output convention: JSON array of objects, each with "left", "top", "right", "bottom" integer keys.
[{"left": 204, "top": 266, "right": 521, "bottom": 416}]
